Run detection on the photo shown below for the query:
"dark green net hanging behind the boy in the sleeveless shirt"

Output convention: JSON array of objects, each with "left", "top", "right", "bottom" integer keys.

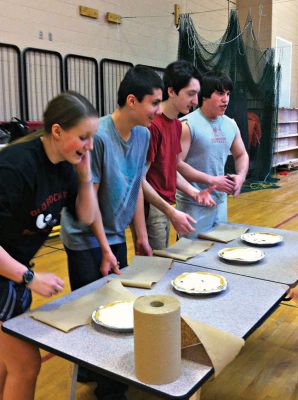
[{"left": 178, "top": 10, "right": 280, "bottom": 181}]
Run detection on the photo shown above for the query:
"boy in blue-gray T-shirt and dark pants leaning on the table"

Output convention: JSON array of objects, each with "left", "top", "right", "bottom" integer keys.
[{"left": 61, "top": 66, "right": 163, "bottom": 400}]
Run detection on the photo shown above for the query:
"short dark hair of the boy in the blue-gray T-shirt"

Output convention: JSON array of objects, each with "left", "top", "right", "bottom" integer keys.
[{"left": 118, "top": 65, "right": 163, "bottom": 107}]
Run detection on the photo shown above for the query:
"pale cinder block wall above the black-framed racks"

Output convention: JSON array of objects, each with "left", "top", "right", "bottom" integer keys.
[{"left": 0, "top": 0, "right": 234, "bottom": 67}]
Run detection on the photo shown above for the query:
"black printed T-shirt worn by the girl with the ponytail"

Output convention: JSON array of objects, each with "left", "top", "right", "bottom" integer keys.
[{"left": 0, "top": 138, "right": 77, "bottom": 268}]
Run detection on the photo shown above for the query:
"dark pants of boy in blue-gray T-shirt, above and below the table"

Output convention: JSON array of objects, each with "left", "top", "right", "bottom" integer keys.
[{"left": 64, "top": 242, "right": 127, "bottom": 400}]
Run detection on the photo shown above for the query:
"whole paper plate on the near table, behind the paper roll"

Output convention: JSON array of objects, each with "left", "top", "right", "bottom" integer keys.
[{"left": 171, "top": 272, "right": 227, "bottom": 294}]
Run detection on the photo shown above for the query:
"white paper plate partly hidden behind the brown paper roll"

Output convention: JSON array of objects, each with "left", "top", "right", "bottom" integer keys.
[{"left": 92, "top": 301, "right": 134, "bottom": 332}]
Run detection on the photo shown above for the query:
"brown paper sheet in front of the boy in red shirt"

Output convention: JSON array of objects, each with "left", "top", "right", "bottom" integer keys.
[{"left": 153, "top": 238, "right": 213, "bottom": 261}]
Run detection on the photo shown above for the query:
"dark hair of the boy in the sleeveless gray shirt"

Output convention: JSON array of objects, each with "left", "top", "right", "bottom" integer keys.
[{"left": 199, "top": 71, "right": 234, "bottom": 107}]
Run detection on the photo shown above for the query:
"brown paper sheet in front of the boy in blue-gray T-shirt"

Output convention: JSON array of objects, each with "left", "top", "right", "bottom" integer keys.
[{"left": 118, "top": 256, "right": 173, "bottom": 289}]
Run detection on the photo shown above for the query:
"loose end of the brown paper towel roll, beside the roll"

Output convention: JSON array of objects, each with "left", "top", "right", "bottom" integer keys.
[{"left": 181, "top": 316, "right": 245, "bottom": 376}]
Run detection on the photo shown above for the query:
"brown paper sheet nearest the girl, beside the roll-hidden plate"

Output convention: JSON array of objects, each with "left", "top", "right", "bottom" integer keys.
[{"left": 30, "top": 279, "right": 137, "bottom": 332}]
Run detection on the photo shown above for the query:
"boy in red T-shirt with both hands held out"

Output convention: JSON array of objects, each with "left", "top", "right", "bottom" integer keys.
[{"left": 143, "top": 60, "right": 215, "bottom": 249}]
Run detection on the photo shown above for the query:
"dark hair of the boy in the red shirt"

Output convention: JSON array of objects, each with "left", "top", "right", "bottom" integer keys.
[{"left": 163, "top": 60, "right": 202, "bottom": 100}]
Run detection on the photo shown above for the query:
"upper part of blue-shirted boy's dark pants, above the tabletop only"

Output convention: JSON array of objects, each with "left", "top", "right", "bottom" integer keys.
[{"left": 64, "top": 242, "right": 127, "bottom": 290}]
